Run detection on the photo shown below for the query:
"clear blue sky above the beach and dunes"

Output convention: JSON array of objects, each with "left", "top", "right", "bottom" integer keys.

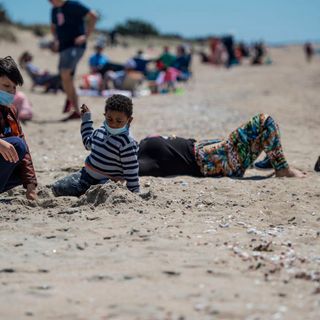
[{"left": 0, "top": 0, "right": 320, "bottom": 43}]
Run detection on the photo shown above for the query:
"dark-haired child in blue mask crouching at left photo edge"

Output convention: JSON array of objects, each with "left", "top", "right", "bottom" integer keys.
[{"left": 0, "top": 57, "right": 37, "bottom": 200}]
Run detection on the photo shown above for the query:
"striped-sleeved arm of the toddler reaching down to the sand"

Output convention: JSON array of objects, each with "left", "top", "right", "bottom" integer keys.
[{"left": 120, "top": 142, "right": 140, "bottom": 192}]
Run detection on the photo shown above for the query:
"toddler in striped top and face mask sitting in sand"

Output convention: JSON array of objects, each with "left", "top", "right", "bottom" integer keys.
[{"left": 52, "top": 94, "right": 140, "bottom": 197}]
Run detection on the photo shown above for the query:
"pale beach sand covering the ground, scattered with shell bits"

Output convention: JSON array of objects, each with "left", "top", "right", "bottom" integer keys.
[{"left": 0, "top": 31, "right": 320, "bottom": 320}]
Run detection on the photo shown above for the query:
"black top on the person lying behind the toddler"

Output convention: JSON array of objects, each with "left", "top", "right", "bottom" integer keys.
[{"left": 138, "top": 136, "right": 202, "bottom": 177}]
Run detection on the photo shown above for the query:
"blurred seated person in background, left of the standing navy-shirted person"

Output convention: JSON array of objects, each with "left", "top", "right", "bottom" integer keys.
[{"left": 19, "top": 51, "right": 63, "bottom": 92}]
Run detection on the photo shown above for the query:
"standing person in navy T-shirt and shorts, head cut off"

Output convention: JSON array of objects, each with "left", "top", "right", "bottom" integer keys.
[{"left": 49, "top": 0, "right": 97, "bottom": 120}]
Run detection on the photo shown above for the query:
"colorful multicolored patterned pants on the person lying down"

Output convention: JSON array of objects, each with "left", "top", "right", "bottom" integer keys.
[{"left": 195, "top": 114, "right": 288, "bottom": 177}]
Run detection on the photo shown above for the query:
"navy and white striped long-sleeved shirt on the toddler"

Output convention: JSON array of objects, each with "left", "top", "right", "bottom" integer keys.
[{"left": 81, "top": 112, "right": 140, "bottom": 192}]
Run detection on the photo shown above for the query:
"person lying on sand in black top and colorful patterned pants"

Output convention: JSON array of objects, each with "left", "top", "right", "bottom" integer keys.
[{"left": 138, "top": 114, "right": 305, "bottom": 178}]
